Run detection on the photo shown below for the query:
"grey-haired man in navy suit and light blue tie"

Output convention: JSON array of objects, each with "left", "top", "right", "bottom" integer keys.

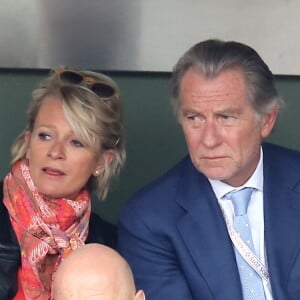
[{"left": 119, "top": 40, "right": 300, "bottom": 300}]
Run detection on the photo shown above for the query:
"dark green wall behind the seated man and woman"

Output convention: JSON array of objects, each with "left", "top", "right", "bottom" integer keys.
[{"left": 0, "top": 69, "right": 300, "bottom": 222}]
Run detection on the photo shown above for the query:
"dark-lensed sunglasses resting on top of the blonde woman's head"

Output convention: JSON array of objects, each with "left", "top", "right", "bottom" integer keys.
[{"left": 57, "top": 70, "right": 118, "bottom": 100}]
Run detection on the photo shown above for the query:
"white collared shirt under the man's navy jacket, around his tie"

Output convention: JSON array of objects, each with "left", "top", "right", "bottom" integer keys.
[{"left": 209, "top": 149, "right": 273, "bottom": 300}]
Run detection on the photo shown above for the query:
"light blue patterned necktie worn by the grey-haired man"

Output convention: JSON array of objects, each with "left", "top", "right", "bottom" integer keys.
[{"left": 226, "top": 188, "right": 265, "bottom": 300}]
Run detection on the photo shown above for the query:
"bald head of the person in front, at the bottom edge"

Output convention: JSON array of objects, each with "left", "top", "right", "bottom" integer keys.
[{"left": 53, "top": 244, "right": 145, "bottom": 300}]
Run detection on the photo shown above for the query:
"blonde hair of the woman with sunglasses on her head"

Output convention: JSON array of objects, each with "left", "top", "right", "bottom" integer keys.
[{"left": 12, "top": 68, "right": 126, "bottom": 199}]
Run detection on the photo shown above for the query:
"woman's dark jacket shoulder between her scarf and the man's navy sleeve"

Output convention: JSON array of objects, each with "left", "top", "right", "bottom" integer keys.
[{"left": 86, "top": 212, "right": 117, "bottom": 249}]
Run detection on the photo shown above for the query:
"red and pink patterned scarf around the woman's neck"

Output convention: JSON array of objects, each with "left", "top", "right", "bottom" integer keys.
[{"left": 4, "top": 161, "right": 91, "bottom": 300}]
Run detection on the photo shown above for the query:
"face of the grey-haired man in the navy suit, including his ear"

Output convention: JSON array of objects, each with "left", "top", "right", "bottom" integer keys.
[{"left": 179, "top": 68, "right": 277, "bottom": 186}]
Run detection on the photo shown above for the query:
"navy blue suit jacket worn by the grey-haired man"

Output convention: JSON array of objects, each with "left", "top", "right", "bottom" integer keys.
[{"left": 119, "top": 144, "right": 300, "bottom": 300}]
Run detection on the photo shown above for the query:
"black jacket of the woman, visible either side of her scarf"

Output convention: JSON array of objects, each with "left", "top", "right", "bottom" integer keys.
[{"left": 0, "top": 182, "right": 117, "bottom": 300}]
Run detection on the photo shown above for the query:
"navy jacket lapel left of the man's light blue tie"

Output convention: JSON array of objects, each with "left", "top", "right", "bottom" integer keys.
[{"left": 177, "top": 164, "right": 242, "bottom": 300}]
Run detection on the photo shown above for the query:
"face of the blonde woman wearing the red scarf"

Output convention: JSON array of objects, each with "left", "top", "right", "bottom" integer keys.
[{"left": 26, "top": 96, "right": 103, "bottom": 199}]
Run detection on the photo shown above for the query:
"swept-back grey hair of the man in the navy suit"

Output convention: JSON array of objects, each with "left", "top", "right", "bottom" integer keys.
[{"left": 172, "top": 39, "right": 284, "bottom": 115}]
